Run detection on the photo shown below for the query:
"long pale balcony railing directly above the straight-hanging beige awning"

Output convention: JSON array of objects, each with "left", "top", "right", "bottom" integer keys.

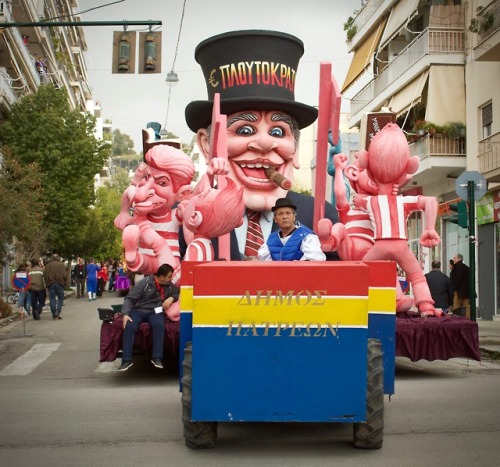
[{"left": 351, "top": 28, "right": 465, "bottom": 115}]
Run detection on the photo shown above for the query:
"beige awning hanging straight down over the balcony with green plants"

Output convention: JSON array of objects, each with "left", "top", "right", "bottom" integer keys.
[{"left": 425, "top": 65, "right": 465, "bottom": 125}]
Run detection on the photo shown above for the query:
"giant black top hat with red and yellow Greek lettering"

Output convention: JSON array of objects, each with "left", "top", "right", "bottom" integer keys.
[{"left": 185, "top": 30, "right": 318, "bottom": 132}]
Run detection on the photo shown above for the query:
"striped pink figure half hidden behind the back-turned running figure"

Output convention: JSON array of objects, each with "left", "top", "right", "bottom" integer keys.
[{"left": 318, "top": 153, "right": 413, "bottom": 311}]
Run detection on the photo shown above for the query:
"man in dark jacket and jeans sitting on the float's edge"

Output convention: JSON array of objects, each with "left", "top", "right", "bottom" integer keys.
[{"left": 119, "top": 264, "right": 179, "bottom": 371}]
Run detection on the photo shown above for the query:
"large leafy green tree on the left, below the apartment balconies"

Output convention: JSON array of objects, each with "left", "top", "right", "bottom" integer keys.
[{"left": 0, "top": 85, "right": 109, "bottom": 257}]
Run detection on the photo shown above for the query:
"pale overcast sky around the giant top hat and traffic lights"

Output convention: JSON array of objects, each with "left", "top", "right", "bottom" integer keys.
[{"left": 79, "top": 0, "right": 361, "bottom": 152}]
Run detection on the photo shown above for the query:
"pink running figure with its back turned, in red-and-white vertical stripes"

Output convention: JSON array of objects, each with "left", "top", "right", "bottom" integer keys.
[{"left": 354, "top": 123, "right": 440, "bottom": 316}]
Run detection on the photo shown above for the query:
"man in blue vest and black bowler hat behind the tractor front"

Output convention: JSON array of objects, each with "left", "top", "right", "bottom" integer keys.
[{"left": 259, "top": 198, "right": 326, "bottom": 261}]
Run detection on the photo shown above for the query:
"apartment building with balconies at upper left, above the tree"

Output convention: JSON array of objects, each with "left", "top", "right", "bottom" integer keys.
[{"left": 0, "top": 0, "right": 98, "bottom": 119}]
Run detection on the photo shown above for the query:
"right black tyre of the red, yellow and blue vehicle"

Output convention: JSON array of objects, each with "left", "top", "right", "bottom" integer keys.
[{"left": 354, "top": 339, "right": 384, "bottom": 449}]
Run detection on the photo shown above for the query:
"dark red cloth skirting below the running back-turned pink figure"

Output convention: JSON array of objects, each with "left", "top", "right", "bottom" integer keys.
[{"left": 396, "top": 315, "right": 481, "bottom": 362}]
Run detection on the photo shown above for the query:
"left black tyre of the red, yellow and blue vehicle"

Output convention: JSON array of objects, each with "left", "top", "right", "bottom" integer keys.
[{"left": 181, "top": 342, "right": 217, "bottom": 449}]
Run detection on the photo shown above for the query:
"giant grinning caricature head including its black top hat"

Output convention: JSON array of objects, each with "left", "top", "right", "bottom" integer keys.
[{"left": 186, "top": 30, "right": 317, "bottom": 211}]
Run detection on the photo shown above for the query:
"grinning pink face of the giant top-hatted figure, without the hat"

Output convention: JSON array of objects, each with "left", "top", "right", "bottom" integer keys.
[{"left": 198, "top": 110, "right": 299, "bottom": 211}]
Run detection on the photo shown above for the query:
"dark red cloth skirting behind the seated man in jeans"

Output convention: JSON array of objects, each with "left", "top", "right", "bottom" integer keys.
[{"left": 99, "top": 313, "right": 180, "bottom": 362}]
